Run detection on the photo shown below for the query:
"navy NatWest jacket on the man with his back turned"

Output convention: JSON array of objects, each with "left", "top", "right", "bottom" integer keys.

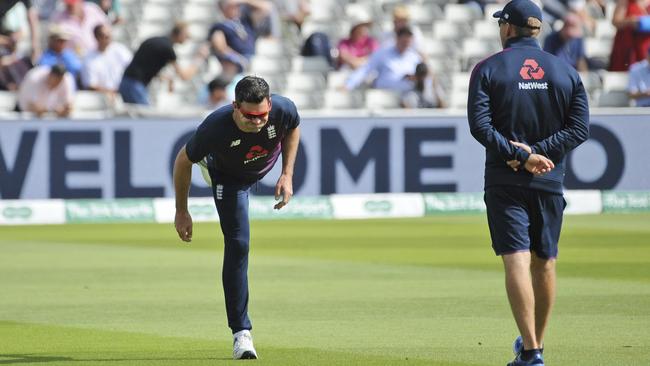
[{"left": 467, "top": 37, "right": 589, "bottom": 193}]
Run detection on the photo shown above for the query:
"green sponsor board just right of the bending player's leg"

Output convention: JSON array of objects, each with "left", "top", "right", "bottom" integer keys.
[{"left": 249, "top": 197, "right": 334, "bottom": 219}]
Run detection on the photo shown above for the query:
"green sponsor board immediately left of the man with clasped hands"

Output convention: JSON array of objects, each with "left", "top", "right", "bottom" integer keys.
[{"left": 423, "top": 193, "right": 485, "bottom": 215}]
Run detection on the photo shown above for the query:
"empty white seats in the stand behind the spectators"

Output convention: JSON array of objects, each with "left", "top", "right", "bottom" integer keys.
[{"left": 0, "top": 0, "right": 630, "bottom": 115}]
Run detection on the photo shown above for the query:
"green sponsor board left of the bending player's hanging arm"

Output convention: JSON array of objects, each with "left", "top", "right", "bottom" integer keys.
[{"left": 65, "top": 198, "right": 155, "bottom": 223}]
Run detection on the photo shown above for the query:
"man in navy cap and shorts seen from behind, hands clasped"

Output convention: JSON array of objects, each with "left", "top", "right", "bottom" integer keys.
[{"left": 467, "top": 0, "right": 589, "bottom": 366}]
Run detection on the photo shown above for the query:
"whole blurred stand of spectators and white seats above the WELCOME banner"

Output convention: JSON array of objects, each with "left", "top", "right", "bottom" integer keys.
[{"left": 0, "top": 0, "right": 650, "bottom": 119}]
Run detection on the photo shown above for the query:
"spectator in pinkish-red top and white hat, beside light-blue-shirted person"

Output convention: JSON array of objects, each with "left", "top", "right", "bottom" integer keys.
[{"left": 337, "top": 16, "right": 379, "bottom": 70}]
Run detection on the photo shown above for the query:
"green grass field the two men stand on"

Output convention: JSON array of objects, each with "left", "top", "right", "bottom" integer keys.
[{"left": 0, "top": 214, "right": 650, "bottom": 366}]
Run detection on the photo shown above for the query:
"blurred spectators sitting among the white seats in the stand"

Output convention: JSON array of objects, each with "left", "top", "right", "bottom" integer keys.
[{"left": 0, "top": 0, "right": 650, "bottom": 117}]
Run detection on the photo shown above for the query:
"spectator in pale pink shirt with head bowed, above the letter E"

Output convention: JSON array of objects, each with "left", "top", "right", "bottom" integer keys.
[{"left": 18, "top": 65, "right": 76, "bottom": 117}]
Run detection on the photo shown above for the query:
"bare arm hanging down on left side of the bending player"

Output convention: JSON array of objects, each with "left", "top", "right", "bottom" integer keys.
[{"left": 174, "top": 147, "right": 192, "bottom": 242}]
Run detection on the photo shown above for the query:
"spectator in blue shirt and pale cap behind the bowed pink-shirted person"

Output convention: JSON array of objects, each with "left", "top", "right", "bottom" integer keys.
[{"left": 38, "top": 25, "right": 82, "bottom": 80}]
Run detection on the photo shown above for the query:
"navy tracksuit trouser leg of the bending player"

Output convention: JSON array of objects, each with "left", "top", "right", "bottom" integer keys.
[{"left": 212, "top": 184, "right": 252, "bottom": 333}]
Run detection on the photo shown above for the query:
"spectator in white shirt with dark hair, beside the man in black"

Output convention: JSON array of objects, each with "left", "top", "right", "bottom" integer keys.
[{"left": 81, "top": 24, "right": 133, "bottom": 97}]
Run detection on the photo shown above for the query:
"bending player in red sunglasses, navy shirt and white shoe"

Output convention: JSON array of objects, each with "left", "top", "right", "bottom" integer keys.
[{"left": 174, "top": 76, "right": 300, "bottom": 359}]
